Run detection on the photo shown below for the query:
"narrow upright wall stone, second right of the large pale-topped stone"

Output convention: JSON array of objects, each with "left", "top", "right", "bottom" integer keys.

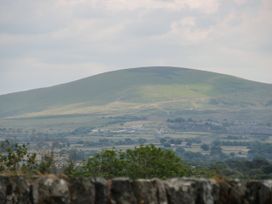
[{"left": 92, "top": 178, "right": 110, "bottom": 204}]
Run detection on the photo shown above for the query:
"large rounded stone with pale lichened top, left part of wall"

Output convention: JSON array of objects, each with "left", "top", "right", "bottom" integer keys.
[{"left": 33, "top": 175, "right": 70, "bottom": 204}]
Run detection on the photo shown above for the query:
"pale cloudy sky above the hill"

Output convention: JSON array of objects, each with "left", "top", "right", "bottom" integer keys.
[{"left": 0, "top": 0, "right": 272, "bottom": 94}]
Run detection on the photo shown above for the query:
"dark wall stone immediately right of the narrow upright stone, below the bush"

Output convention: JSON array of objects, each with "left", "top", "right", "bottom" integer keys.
[{"left": 110, "top": 178, "right": 137, "bottom": 204}]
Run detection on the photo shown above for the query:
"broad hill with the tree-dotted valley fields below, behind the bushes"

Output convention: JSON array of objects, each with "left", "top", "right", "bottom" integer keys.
[{"left": 0, "top": 67, "right": 272, "bottom": 165}]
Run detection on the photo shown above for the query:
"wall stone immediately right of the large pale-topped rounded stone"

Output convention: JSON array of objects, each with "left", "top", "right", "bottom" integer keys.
[{"left": 69, "top": 178, "right": 95, "bottom": 204}]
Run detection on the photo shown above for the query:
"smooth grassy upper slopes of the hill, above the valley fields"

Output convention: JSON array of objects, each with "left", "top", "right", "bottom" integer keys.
[{"left": 0, "top": 67, "right": 272, "bottom": 117}]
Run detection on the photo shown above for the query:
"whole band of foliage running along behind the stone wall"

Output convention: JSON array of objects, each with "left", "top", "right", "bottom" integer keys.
[{"left": 3, "top": 141, "right": 272, "bottom": 179}]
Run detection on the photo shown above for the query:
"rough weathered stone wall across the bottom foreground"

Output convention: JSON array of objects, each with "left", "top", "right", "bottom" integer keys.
[{"left": 0, "top": 175, "right": 272, "bottom": 204}]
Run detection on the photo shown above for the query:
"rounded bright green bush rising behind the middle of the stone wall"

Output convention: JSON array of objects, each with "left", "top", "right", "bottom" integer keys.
[{"left": 66, "top": 145, "right": 191, "bottom": 178}]
